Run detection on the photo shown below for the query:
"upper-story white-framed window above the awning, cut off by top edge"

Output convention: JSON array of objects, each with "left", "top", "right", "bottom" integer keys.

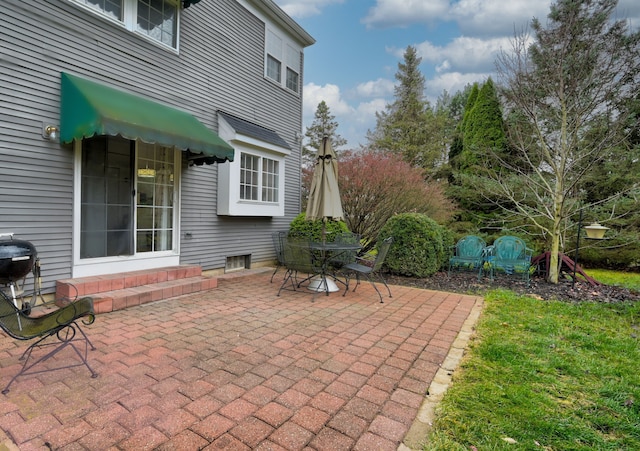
[{"left": 73, "top": 0, "right": 180, "bottom": 48}]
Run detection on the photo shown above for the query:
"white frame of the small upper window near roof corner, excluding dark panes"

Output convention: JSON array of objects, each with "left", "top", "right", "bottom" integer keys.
[{"left": 264, "top": 26, "right": 302, "bottom": 95}]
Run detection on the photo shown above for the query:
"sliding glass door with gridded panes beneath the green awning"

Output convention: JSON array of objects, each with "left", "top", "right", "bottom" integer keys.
[{"left": 80, "top": 136, "right": 176, "bottom": 259}]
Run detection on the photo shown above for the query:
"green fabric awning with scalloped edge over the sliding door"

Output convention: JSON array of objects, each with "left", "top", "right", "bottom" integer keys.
[{"left": 60, "top": 72, "right": 234, "bottom": 163}]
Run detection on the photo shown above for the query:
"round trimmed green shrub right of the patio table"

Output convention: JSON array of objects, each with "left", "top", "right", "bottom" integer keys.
[{"left": 378, "top": 213, "right": 452, "bottom": 277}]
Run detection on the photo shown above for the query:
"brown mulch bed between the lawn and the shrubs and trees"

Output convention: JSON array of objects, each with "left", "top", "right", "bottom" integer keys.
[{"left": 385, "top": 271, "right": 640, "bottom": 303}]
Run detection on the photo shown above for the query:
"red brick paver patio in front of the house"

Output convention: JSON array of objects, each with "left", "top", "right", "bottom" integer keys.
[{"left": 0, "top": 272, "right": 480, "bottom": 451}]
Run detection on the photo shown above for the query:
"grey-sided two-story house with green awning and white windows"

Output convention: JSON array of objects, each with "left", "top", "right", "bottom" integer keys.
[{"left": 0, "top": 0, "right": 314, "bottom": 308}]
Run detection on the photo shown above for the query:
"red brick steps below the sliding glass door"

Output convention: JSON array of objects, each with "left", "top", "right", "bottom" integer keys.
[{"left": 56, "top": 265, "right": 218, "bottom": 313}]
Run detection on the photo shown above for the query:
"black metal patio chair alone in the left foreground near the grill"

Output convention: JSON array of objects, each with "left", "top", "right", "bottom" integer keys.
[{"left": 0, "top": 291, "right": 98, "bottom": 394}]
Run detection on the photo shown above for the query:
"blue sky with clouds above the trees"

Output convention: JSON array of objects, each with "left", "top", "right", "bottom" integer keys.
[{"left": 274, "top": 0, "right": 640, "bottom": 152}]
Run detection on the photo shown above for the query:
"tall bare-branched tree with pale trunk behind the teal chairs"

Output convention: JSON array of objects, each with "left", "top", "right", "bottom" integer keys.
[{"left": 482, "top": 0, "right": 640, "bottom": 283}]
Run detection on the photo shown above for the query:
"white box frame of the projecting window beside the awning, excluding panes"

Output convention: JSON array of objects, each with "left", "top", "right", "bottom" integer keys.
[{"left": 217, "top": 116, "right": 291, "bottom": 216}]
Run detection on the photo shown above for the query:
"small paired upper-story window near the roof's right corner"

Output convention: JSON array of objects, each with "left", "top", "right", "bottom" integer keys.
[{"left": 265, "top": 29, "right": 302, "bottom": 93}]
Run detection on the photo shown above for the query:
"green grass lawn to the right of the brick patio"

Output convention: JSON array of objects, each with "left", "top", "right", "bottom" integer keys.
[{"left": 424, "top": 278, "right": 640, "bottom": 451}]
